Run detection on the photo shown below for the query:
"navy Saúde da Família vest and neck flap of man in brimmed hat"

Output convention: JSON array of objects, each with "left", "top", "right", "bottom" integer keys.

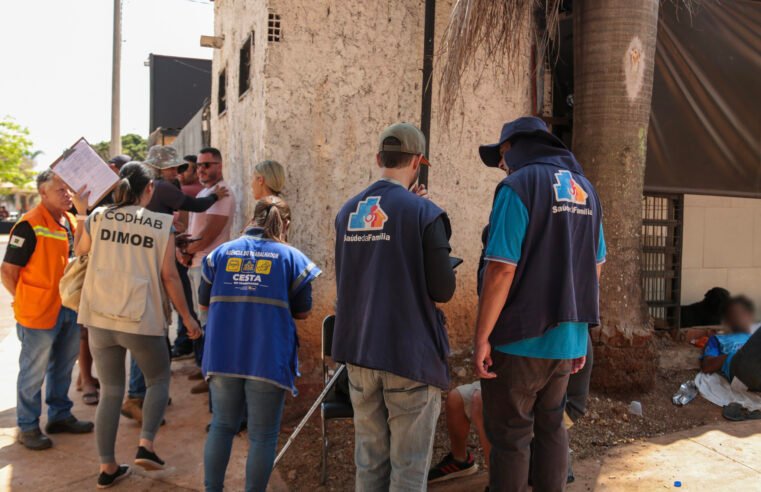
[{"left": 489, "top": 138, "right": 602, "bottom": 346}]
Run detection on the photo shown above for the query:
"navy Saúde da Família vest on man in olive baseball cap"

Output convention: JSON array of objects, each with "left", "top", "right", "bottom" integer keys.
[{"left": 333, "top": 179, "right": 449, "bottom": 389}]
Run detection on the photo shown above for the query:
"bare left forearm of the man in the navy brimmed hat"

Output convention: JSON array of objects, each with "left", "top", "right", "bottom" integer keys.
[{"left": 473, "top": 261, "right": 515, "bottom": 379}]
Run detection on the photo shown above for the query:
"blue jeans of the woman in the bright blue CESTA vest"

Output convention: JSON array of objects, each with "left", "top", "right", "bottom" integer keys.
[{"left": 203, "top": 376, "right": 285, "bottom": 492}]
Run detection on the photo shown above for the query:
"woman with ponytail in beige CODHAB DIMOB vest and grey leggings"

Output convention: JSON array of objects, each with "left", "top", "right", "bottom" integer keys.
[{"left": 74, "top": 162, "right": 201, "bottom": 488}]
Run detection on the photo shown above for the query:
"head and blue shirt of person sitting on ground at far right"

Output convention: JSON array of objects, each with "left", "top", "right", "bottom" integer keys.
[{"left": 700, "top": 296, "right": 756, "bottom": 382}]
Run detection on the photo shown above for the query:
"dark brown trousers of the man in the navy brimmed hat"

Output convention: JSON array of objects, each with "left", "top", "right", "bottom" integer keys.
[{"left": 481, "top": 351, "right": 571, "bottom": 492}]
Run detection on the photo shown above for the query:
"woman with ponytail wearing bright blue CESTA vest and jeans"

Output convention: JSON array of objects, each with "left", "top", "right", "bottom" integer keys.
[{"left": 199, "top": 196, "right": 321, "bottom": 492}]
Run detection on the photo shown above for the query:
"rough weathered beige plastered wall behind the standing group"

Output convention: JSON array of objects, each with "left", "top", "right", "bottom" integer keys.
[{"left": 211, "top": 0, "right": 531, "bottom": 372}]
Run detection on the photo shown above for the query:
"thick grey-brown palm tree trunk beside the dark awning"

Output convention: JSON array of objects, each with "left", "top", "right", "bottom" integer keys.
[{"left": 573, "top": 0, "right": 658, "bottom": 391}]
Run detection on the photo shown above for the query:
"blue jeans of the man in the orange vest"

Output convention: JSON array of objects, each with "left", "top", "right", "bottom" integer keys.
[{"left": 16, "top": 307, "right": 79, "bottom": 432}]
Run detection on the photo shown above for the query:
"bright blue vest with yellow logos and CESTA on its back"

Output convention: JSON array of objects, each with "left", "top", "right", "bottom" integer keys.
[{"left": 202, "top": 228, "right": 321, "bottom": 395}]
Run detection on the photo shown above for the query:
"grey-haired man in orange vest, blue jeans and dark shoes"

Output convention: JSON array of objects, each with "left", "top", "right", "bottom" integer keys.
[{"left": 0, "top": 170, "right": 93, "bottom": 450}]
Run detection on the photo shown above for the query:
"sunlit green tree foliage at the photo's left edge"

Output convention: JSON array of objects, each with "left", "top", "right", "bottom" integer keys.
[{"left": 0, "top": 116, "right": 37, "bottom": 190}]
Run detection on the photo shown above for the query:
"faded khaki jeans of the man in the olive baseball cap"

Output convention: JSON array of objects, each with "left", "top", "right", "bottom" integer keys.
[{"left": 347, "top": 365, "right": 441, "bottom": 492}]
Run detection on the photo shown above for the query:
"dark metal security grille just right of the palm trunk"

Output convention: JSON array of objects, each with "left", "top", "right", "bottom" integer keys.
[{"left": 642, "top": 194, "right": 684, "bottom": 329}]
